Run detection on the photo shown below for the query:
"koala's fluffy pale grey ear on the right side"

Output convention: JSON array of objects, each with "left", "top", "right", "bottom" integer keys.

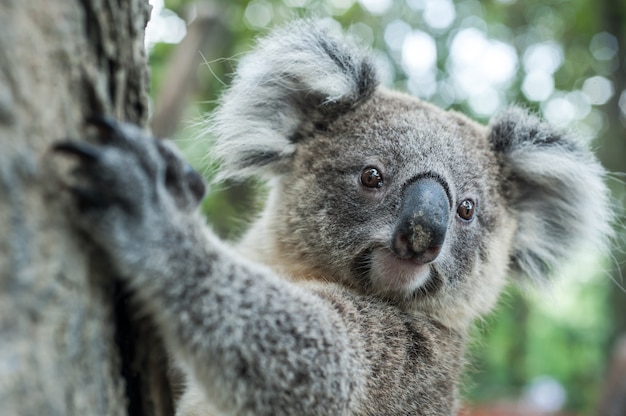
[{"left": 490, "top": 108, "right": 612, "bottom": 280}]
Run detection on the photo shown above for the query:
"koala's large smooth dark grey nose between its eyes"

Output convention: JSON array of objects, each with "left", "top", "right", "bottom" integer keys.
[{"left": 391, "top": 178, "right": 450, "bottom": 264}]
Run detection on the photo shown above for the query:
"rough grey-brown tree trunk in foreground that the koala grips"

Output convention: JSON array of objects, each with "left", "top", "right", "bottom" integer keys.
[{"left": 0, "top": 0, "right": 171, "bottom": 415}]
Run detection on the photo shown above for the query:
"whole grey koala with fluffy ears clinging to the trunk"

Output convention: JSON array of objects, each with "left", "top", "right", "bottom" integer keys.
[{"left": 55, "top": 20, "right": 611, "bottom": 415}]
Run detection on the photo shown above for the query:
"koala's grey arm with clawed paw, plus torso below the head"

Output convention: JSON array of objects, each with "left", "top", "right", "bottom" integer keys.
[{"left": 56, "top": 120, "right": 462, "bottom": 415}]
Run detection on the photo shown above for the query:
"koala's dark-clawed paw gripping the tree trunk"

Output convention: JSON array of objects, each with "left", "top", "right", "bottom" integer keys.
[{"left": 53, "top": 117, "right": 204, "bottom": 255}]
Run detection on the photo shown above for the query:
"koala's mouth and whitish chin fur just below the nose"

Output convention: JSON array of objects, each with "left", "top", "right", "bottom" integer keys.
[{"left": 370, "top": 248, "right": 430, "bottom": 295}]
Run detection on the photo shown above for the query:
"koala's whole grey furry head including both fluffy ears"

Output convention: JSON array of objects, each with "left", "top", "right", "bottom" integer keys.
[{"left": 213, "top": 21, "right": 609, "bottom": 326}]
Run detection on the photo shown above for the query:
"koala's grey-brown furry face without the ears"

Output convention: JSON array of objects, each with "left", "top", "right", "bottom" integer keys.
[{"left": 274, "top": 89, "right": 512, "bottom": 324}]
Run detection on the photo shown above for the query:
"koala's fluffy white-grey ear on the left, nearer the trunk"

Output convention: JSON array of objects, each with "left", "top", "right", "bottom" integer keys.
[{"left": 212, "top": 20, "right": 378, "bottom": 178}]
